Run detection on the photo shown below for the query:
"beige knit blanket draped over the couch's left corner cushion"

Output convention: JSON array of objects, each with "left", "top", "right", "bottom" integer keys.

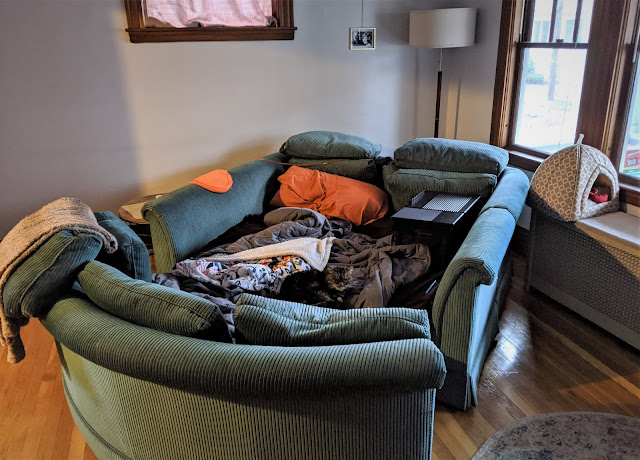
[{"left": 0, "top": 198, "right": 118, "bottom": 363}]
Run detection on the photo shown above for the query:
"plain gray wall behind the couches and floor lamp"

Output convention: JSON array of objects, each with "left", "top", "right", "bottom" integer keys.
[{"left": 0, "top": 0, "right": 500, "bottom": 236}]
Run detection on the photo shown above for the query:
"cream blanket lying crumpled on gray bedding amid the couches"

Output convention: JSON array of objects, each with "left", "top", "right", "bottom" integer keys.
[{"left": 205, "top": 237, "right": 335, "bottom": 270}]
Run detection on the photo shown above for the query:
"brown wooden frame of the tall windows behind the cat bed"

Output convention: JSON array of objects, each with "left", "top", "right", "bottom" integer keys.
[{"left": 490, "top": 0, "right": 640, "bottom": 206}]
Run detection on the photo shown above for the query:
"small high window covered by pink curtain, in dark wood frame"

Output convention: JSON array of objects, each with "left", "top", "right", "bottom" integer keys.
[{"left": 124, "top": 0, "right": 296, "bottom": 43}]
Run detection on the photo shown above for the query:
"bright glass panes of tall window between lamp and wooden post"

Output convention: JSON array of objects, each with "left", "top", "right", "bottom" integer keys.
[{"left": 513, "top": 0, "right": 593, "bottom": 153}]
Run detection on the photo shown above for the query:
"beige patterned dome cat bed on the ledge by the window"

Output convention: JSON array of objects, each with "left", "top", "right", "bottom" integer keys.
[{"left": 527, "top": 142, "right": 620, "bottom": 222}]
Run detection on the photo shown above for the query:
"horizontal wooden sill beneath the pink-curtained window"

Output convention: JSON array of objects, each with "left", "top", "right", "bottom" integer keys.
[{"left": 127, "top": 27, "right": 296, "bottom": 43}]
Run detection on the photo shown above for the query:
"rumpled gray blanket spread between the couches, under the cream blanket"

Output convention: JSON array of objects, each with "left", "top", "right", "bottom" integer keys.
[{"left": 153, "top": 208, "right": 430, "bottom": 332}]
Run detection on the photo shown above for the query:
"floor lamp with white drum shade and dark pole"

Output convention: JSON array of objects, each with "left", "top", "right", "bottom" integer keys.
[{"left": 409, "top": 8, "right": 477, "bottom": 137}]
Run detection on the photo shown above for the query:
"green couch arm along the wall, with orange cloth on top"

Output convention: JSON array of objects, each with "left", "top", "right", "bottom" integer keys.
[{"left": 142, "top": 153, "right": 287, "bottom": 273}]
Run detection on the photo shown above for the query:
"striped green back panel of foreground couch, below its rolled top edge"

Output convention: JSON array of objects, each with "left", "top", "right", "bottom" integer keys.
[{"left": 60, "top": 340, "right": 435, "bottom": 460}]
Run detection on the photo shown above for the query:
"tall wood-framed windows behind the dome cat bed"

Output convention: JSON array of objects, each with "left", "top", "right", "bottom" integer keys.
[{"left": 491, "top": 0, "right": 640, "bottom": 193}]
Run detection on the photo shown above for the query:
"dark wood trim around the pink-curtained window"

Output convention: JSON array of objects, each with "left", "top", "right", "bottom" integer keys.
[{"left": 124, "top": 0, "right": 296, "bottom": 43}]
